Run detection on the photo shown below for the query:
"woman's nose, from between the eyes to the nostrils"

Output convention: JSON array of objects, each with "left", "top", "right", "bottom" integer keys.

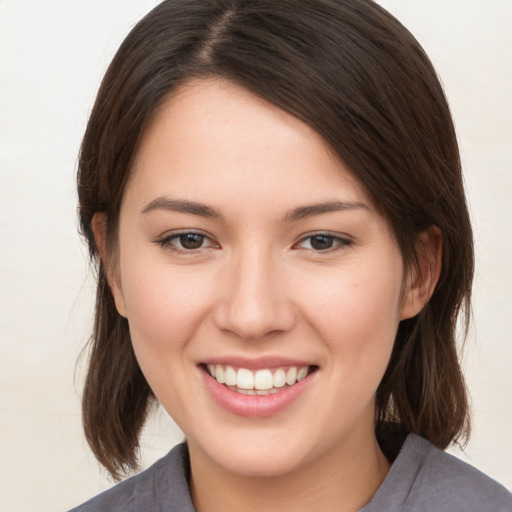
[{"left": 214, "top": 247, "right": 296, "bottom": 340}]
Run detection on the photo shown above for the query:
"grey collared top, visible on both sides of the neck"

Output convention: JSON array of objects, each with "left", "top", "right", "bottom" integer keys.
[{"left": 70, "top": 434, "right": 512, "bottom": 512}]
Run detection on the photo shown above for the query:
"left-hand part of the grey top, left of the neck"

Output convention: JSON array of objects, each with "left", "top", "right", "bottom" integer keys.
[{"left": 70, "top": 444, "right": 194, "bottom": 512}]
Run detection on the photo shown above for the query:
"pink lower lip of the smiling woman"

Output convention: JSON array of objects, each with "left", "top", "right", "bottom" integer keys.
[{"left": 201, "top": 369, "right": 316, "bottom": 418}]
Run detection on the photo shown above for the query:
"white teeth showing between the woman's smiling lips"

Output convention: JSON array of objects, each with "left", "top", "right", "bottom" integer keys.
[{"left": 204, "top": 364, "right": 318, "bottom": 396}]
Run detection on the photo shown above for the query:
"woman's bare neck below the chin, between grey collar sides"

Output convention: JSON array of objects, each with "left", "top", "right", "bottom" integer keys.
[{"left": 189, "top": 428, "right": 389, "bottom": 512}]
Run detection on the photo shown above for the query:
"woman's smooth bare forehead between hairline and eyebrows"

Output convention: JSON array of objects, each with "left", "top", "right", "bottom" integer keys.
[{"left": 126, "top": 79, "right": 372, "bottom": 216}]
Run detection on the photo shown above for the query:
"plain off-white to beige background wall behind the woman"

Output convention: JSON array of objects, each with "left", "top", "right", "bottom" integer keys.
[{"left": 0, "top": 0, "right": 512, "bottom": 512}]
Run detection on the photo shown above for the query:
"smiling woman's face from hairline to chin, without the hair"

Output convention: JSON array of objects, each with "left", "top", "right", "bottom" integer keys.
[{"left": 107, "top": 80, "right": 415, "bottom": 475}]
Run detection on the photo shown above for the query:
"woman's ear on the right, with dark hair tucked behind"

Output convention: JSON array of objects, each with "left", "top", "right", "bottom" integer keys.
[{"left": 400, "top": 226, "right": 443, "bottom": 320}]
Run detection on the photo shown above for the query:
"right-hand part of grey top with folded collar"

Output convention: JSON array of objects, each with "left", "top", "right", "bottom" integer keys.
[{"left": 363, "top": 434, "right": 512, "bottom": 512}]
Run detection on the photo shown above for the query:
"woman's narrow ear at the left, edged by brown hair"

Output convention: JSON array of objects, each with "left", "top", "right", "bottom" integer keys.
[{"left": 91, "top": 212, "right": 126, "bottom": 318}]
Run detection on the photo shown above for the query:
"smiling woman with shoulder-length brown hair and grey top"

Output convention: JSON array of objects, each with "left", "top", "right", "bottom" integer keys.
[{"left": 70, "top": 0, "right": 512, "bottom": 512}]
